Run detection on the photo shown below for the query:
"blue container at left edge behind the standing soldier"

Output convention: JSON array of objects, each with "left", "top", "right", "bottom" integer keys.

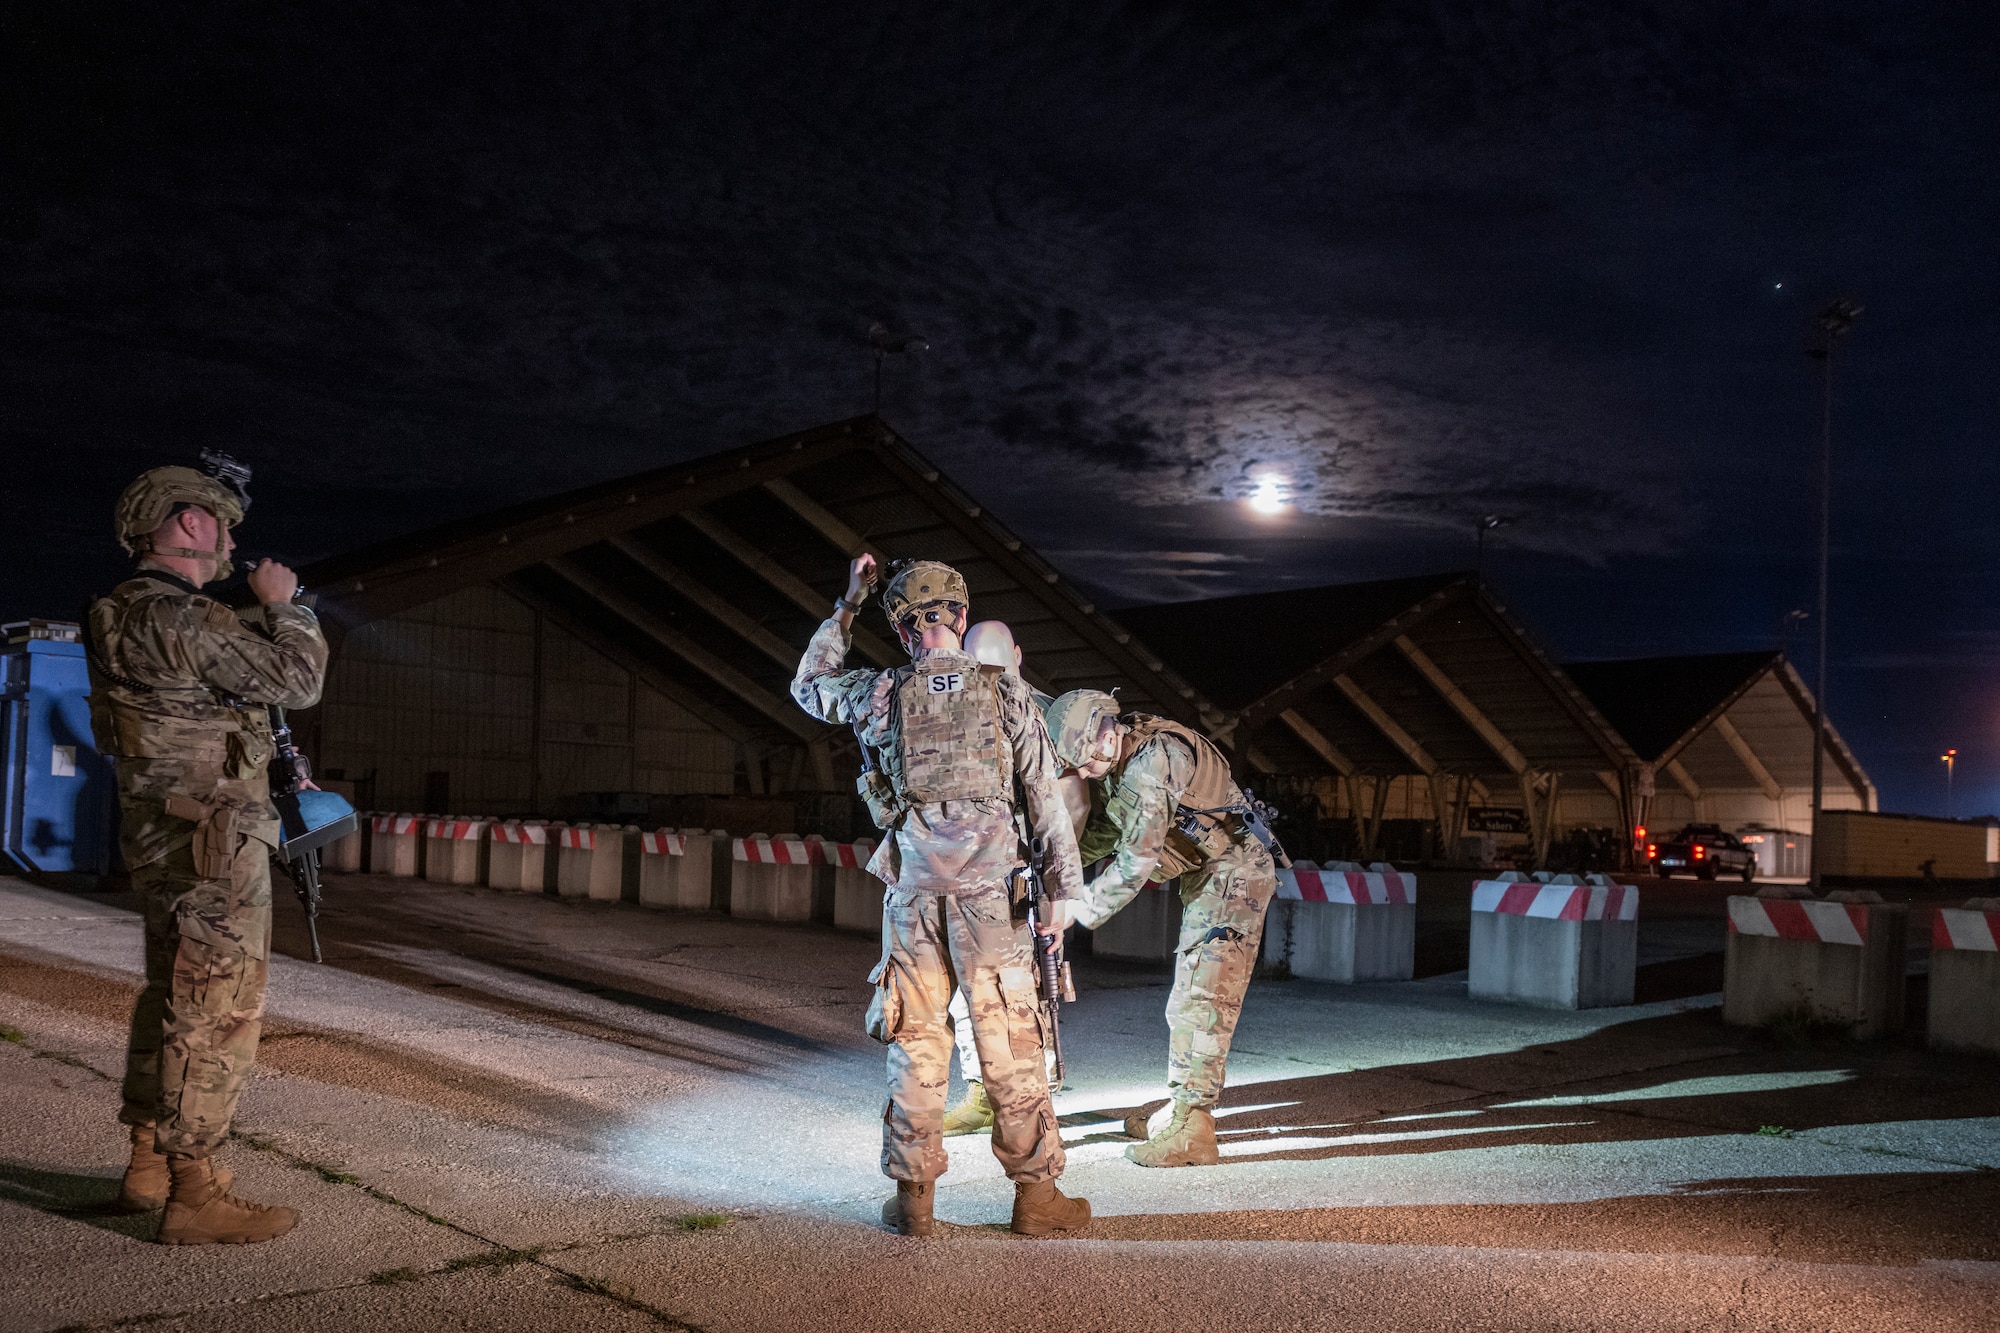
[{"left": 0, "top": 620, "right": 118, "bottom": 875}]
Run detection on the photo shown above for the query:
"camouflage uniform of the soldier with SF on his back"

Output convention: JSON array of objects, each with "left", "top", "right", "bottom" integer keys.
[{"left": 792, "top": 618, "right": 1082, "bottom": 1185}]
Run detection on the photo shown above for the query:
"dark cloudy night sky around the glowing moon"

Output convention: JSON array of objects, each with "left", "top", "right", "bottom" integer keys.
[{"left": 0, "top": 0, "right": 2000, "bottom": 815}]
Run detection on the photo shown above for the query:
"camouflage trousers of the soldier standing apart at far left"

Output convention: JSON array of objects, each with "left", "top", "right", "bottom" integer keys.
[{"left": 118, "top": 835, "right": 270, "bottom": 1157}]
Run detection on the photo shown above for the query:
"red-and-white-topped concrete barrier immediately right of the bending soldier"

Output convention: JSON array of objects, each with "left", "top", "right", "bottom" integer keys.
[{"left": 1262, "top": 861, "right": 1416, "bottom": 983}]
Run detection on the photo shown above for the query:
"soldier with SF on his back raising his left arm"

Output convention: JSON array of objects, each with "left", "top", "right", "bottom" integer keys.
[{"left": 792, "top": 554, "right": 1090, "bottom": 1235}]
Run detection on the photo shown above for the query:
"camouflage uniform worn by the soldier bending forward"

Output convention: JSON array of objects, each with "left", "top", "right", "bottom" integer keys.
[{"left": 1076, "top": 715, "right": 1278, "bottom": 1109}]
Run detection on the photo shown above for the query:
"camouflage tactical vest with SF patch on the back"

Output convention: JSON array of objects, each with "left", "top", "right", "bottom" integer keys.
[{"left": 882, "top": 656, "right": 1014, "bottom": 805}]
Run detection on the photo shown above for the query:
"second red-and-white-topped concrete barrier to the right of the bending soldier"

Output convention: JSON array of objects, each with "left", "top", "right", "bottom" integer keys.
[{"left": 1466, "top": 871, "right": 1638, "bottom": 1009}]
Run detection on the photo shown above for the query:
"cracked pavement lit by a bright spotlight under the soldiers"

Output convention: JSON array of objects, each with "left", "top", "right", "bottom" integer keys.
[{"left": 0, "top": 860, "right": 2000, "bottom": 1333}]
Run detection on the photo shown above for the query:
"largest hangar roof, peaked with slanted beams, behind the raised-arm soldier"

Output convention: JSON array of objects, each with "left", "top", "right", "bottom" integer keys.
[{"left": 300, "top": 416, "right": 1216, "bottom": 743}]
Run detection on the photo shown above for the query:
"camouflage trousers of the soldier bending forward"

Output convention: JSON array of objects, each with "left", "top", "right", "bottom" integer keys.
[{"left": 1166, "top": 839, "right": 1278, "bottom": 1107}]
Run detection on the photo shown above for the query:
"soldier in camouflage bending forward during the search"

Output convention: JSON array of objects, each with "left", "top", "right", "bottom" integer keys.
[{"left": 1048, "top": 691, "right": 1278, "bottom": 1167}]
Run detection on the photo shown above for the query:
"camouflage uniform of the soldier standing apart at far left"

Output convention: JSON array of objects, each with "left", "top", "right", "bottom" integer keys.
[{"left": 88, "top": 560, "right": 326, "bottom": 1157}]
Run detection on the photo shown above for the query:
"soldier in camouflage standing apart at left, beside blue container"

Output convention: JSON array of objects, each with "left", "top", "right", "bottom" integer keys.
[{"left": 86, "top": 468, "right": 326, "bottom": 1245}]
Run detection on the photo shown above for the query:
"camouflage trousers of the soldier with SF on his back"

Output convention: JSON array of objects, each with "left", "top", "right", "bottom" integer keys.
[{"left": 868, "top": 885, "right": 1064, "bottom": 1185}]
